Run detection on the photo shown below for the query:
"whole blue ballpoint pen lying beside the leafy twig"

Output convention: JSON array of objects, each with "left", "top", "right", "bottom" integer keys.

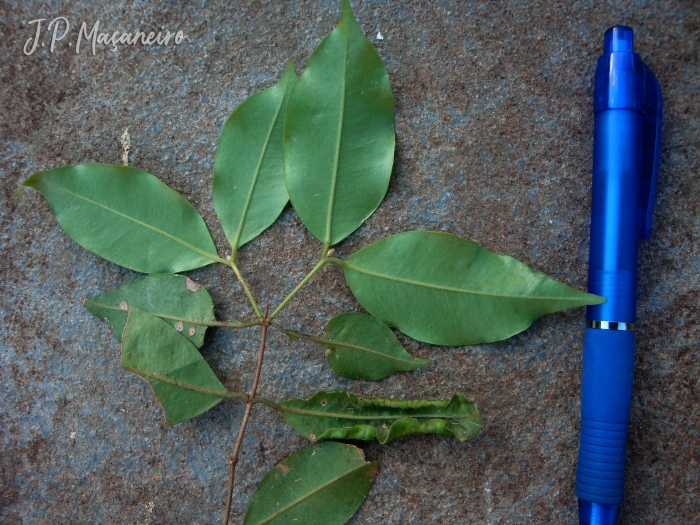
[{"left": 576, "top": 26, "right": 661, "bottom": 525}]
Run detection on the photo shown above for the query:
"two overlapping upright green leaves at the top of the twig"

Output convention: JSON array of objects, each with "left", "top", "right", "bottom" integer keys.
[{"left": 212, "top": 0, "right": 395, "bottom": 253}]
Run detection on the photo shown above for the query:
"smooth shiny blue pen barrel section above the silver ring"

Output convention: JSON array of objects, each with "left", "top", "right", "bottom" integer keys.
[{"left": 586, "top": 109, "right": 642, "bottom": 323}]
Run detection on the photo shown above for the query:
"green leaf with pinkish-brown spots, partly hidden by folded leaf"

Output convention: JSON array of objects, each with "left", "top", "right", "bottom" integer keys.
[{"left": 83, "top": 273, "right": 216, "bottom": 348}]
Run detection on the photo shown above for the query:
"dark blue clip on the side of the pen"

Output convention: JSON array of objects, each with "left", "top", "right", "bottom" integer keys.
[{"left": 639, "top": 62, "right": 662, "bottom": 240}]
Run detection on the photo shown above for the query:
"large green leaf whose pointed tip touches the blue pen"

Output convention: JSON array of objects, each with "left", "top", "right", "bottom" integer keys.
[{"left": 343, "top": 231, "right": 604, "bottom": 345}]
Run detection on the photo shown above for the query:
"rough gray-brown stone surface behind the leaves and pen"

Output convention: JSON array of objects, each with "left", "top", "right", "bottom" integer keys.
[{"left": 0, "top": 0, "right": 700, "bottom": 525}]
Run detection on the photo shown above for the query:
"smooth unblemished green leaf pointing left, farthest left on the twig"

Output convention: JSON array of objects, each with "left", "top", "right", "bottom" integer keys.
[{"left": 23, "top": 164, "right": 218, "bottom": 273}]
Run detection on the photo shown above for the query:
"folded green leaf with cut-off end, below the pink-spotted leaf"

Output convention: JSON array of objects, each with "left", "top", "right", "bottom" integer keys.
[{"left": 121, "top": 306, "right": 226, "bottom": 425}]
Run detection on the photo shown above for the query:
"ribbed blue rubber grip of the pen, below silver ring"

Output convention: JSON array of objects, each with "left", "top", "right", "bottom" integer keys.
[{"left": 576, "top": 328, "right": 634, "bottom": 505}]
